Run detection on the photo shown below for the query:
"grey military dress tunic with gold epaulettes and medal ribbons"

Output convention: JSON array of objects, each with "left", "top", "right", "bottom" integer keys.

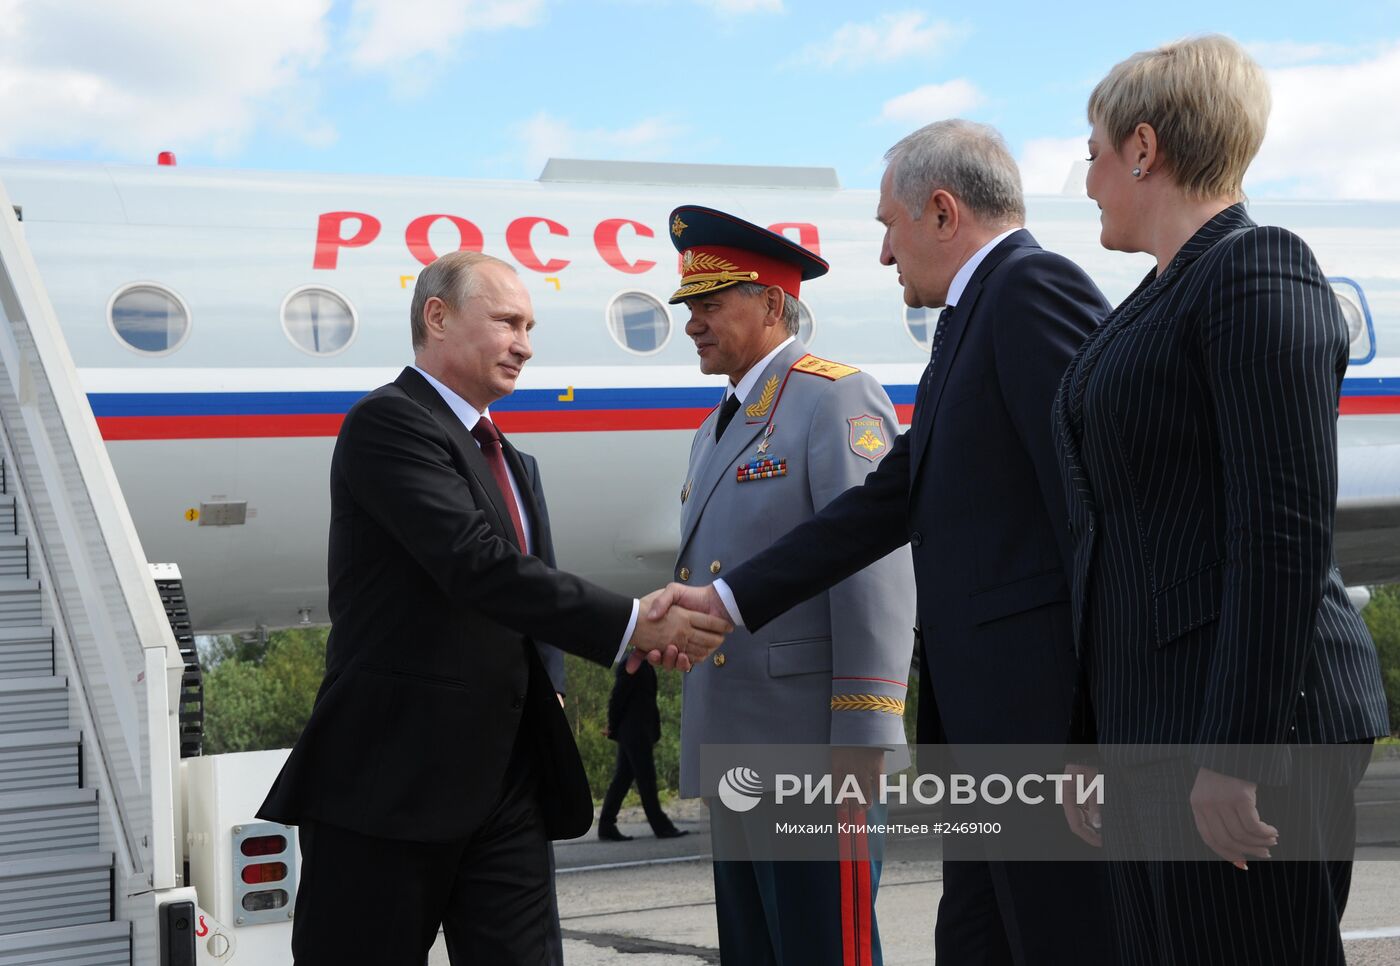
[{"left": 673, "top": 340, "right": 914, "bottom": 797}]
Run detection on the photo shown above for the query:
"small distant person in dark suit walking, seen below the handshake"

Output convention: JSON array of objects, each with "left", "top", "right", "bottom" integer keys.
[{"left": 598, "top": 664, "right": 686, "bottom": 841}]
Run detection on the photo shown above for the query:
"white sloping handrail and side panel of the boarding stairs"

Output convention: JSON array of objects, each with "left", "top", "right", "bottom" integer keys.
[{"left": 0, "top": 182, "right": 183, "bottom": 904}]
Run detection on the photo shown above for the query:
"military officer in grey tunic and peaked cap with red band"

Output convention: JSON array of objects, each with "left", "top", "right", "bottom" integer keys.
[{"left": 669, "top": 206, "right": 914, "bottom": 966}]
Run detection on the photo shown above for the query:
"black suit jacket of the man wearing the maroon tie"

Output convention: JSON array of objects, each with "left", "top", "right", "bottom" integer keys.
[{"left": 259, "top": 368, "right": 631, "bottom": 841}]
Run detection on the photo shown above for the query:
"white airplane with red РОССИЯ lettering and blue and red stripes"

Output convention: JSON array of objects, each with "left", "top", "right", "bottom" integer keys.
[{"left": 0, "top": 155, "right": 1400, "bottom": 633}]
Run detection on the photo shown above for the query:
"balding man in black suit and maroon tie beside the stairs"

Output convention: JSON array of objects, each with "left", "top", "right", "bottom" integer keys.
[{"left": 259, "top": 252, "right": 724, "bottom": 966}]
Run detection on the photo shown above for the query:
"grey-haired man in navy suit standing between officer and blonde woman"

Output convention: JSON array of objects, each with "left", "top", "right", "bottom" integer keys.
[{"left": 654, "top": 120, "right": 1113, "bottom": 966}]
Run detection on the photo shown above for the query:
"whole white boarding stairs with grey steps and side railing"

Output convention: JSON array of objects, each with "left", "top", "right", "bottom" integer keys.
[{"left": 0, "top": 185, "right": 193, "bottom": 966}]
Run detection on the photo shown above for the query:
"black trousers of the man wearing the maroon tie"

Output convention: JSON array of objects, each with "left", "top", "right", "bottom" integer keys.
[{"left": 291, "top": 749, "right": 559, "bottom": 966}]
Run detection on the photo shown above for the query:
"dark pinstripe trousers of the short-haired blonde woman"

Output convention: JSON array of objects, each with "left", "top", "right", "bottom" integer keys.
[{"left": 1103, "top": 742, "right": 1371, "bottom": 966}]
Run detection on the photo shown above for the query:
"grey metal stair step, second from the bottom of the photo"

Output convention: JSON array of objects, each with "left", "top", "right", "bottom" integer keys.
[{"left": 0, "top": 853, "right": 112, "bottom": 935}]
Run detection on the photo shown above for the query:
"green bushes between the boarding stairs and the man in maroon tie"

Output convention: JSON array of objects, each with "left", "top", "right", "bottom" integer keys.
[{"left": 204, "top": 627, "right": 328, "bottom": 755}]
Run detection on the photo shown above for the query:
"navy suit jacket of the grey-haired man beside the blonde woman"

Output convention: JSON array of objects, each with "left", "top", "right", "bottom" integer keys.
[{"left": 727, "top": 230, "right": 1107, "bottom": 743}]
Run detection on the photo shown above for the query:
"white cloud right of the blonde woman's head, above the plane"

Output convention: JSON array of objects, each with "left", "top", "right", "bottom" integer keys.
[{"left": 1245, "top": 43, "right": 1400, "bottom": 199}]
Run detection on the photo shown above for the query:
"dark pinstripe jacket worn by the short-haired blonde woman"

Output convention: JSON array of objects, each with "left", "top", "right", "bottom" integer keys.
[{"left": 1054, "top": 204, "right": 1387, "bottom": 783}]
